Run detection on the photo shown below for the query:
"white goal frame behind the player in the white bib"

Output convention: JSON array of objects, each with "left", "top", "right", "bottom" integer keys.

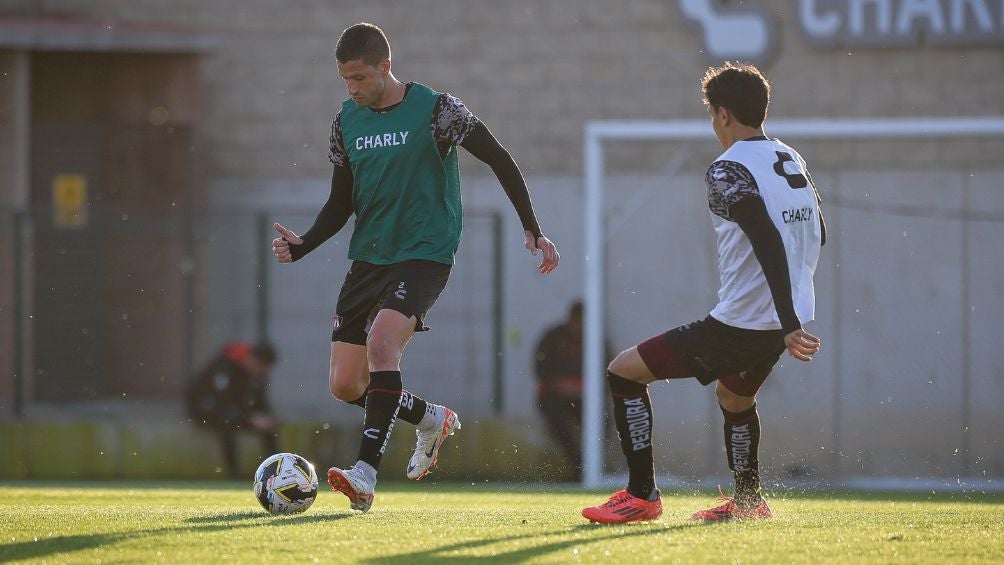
[{"left": 582, "top": 115, "right": 1004, "bottom": 489}]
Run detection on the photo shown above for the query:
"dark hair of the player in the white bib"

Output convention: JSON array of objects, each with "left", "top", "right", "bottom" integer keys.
[{"left": 701, "top": 62, "right": 770, "bottom": 127}]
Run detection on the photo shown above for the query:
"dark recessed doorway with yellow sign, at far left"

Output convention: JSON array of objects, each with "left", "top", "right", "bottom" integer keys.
[{"left": 31, "top": 53, "right": 198, "bottom": 401}]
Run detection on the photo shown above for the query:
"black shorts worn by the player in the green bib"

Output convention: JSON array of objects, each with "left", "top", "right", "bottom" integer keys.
[{"left": 331, "top": 260, "right": 453, "bottom": 345}]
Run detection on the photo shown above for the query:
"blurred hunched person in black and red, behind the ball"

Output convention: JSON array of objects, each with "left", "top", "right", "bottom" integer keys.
[{"left": 186, "top": 342, "right": 279, "bottom": 479}]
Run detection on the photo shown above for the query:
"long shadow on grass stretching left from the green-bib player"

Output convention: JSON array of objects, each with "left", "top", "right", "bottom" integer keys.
[{"left": 0, "top": 512, "right": 351, "bottom": 563}]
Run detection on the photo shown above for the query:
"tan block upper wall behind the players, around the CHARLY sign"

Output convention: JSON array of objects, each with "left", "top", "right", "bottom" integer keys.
[{"left": 0, "top": 0, "right": 1004, "bottom": 179}]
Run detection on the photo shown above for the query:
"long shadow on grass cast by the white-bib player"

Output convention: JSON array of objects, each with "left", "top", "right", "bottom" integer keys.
[{"left": 360, "top": 522, "right": 699, "bottom": 565}]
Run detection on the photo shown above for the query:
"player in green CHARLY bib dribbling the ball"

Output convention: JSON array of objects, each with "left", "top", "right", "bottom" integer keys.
[{"left": 272, "top": 23, "right": 559, "bottom": 512}]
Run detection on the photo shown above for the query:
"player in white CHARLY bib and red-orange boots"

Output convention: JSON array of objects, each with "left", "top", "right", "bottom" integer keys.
[{"left": 582, "top": 63, "right": 825, "bottom": 523}]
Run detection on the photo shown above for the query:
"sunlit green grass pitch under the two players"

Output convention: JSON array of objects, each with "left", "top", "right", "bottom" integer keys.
[{"left": 0, "top": 483, "right": 1004, "bottom": 565}]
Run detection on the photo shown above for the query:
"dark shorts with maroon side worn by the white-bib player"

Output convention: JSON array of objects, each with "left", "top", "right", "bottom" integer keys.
[{"left": 638, "top": 316, "right": 785, "bottom": 396}]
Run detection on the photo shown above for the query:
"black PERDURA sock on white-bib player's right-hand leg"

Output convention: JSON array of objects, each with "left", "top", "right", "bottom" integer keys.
[{"left": 719, "top": 404, "right": 761, "bottom": 506}]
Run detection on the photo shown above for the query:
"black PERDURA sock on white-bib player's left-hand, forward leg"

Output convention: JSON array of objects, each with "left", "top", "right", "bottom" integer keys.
[{"left": 606, "top": 371, "right": 656, "bottom": 500}]
